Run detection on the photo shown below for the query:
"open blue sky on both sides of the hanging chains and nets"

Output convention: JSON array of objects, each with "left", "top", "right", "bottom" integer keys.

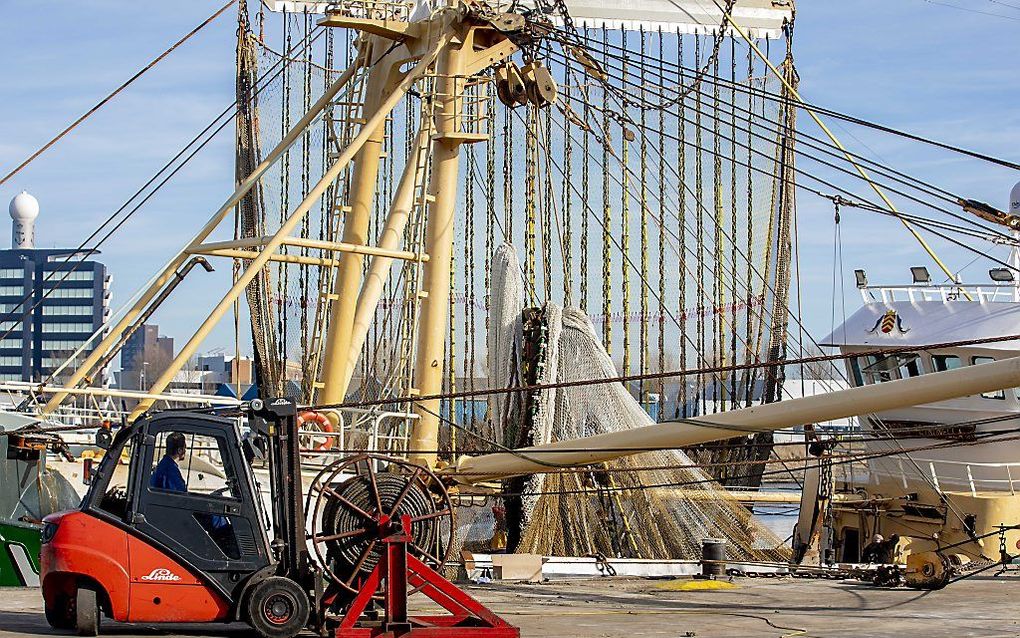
[{"left": 0, "top": 0, "right": 1020, "bottom": 359}]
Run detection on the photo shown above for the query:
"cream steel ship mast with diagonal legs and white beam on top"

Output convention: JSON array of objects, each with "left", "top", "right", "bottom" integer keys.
[{"left": 37, "top": 0, "right": 803, "bottom": 457}]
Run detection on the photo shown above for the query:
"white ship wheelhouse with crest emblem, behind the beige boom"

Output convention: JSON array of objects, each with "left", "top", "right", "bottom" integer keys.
[{"left": 820, "top": 285, "right": 1020, "bottom": 496}]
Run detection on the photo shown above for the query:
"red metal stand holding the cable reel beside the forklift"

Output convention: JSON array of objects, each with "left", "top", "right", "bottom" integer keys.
[{"left": 335, "top": 516, "right": 520, "bottom": 638}]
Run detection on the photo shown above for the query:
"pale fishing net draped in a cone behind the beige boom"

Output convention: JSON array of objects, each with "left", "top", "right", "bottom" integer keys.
[{"left": 477, "top": 240, "right": 787, "bottom": 560}]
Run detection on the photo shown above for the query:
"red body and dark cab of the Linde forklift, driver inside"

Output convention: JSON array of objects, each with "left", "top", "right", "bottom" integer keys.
[{"left": 42, "top": 412, "right": 274, "bottom": 633}]
